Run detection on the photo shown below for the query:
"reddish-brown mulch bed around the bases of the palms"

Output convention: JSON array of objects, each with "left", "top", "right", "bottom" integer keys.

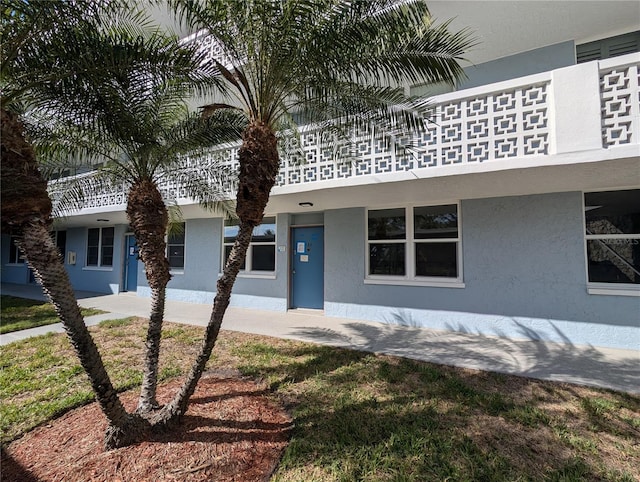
[{"left": 2, "top": 373, "right": 292, "bottom": 482}]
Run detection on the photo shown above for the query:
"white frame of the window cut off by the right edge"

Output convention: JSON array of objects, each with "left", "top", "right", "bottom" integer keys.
[{"left": 581, "top": 187, "right": 640, "bottom": 297}]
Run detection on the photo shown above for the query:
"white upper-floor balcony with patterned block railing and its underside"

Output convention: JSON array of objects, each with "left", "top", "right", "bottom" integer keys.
[{"left": 50, "top": 53, "right": 640, "bottom": 225}]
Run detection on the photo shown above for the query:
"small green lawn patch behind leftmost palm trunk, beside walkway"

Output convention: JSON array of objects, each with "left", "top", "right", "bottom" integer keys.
[{"left": 0, "top": 295, "right": 104, "bottom": 333}]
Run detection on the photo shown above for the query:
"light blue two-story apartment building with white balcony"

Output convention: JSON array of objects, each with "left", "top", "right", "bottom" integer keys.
[{"left": 1, "top": 1, "right": 640, "bottom": 349}]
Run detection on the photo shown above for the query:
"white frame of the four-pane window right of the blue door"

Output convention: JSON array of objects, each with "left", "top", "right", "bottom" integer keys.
[{"left": 364, "top": 201, "right": 465, "bottom": 288}]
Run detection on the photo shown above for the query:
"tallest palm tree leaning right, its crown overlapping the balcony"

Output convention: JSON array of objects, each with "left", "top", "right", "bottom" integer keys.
[{"left": 156, "top": 0, "right": 470, "bottom": 423}]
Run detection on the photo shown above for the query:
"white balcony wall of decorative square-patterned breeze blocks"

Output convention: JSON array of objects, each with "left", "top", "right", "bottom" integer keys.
[{"left": 50, "top": 54, "right": 640, "bottom": 214}]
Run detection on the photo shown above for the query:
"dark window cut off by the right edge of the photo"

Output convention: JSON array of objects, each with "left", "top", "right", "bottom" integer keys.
[{"left": 584, "top": 189, "right": 640, "bottom": 287}]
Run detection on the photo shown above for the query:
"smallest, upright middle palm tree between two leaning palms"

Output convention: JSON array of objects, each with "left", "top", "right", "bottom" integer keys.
[{"left": 35, "top": 82, "right": 244, "bottom": 413}]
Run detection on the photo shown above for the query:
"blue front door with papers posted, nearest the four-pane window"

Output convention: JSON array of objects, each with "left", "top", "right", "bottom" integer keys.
[{"left": 291, "top": 226, "right": 324, "bottom": 310}]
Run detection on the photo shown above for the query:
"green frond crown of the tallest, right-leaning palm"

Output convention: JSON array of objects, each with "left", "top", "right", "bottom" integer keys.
[{"left": 169, "top": 0, "right": 474, "bottom": 140}]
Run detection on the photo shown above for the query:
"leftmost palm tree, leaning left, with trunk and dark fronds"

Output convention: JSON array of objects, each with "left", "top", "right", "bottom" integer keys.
[{"left": 0, "top": 0, "right": 215, "bottom": 448}]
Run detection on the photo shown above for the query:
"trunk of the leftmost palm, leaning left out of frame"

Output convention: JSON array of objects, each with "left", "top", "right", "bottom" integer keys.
[{"left": 1, "top": 109, "right": 148, "bottom": 449}]
